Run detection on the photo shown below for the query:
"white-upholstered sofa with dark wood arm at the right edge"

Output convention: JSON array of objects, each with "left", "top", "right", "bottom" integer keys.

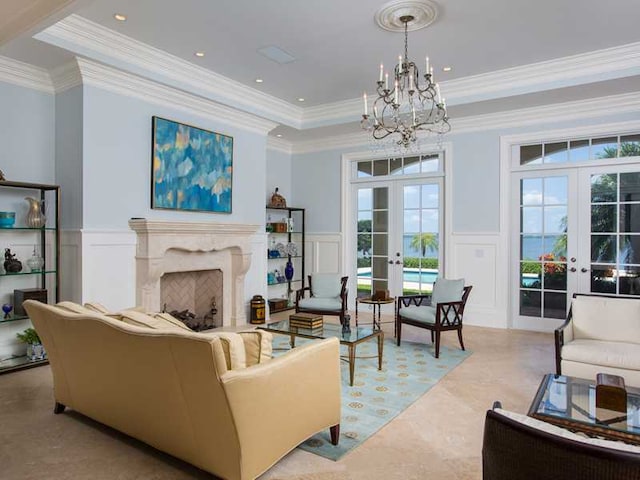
[{"left": 555, "top": 295, "right": 640, "bottom": 387}]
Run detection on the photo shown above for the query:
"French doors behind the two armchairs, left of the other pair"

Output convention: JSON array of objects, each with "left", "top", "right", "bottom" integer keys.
[{"left": 352, "top": 178, "right": 443, "bottom": 302}]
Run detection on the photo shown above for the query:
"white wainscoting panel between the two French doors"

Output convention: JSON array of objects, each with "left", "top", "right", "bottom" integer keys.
[{"left": 447, "top": 233, "right": 508, "bottom": 328}]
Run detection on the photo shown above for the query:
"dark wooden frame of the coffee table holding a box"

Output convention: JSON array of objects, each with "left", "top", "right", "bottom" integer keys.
[{"left": 527, "top": 373, "right": 640, "bottom": 445}]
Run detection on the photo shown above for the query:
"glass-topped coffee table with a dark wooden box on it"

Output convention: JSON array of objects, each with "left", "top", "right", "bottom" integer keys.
[{"left": 528, "top": 374, "right": 640, "bottom": 445}]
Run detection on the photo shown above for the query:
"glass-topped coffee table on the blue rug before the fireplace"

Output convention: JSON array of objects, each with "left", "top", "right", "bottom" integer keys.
[{"left": 258, "top": 320, "right": 384, "bottom": 386}]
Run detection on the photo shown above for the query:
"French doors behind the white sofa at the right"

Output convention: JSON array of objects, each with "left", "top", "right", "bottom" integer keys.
[{"left": 511, "top": 165, "right": 640, "bottom": 331}]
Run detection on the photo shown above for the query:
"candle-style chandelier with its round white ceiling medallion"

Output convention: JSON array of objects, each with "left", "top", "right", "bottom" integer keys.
[{"left": 361, "top": 0, "right": 451, "bottom": 149}]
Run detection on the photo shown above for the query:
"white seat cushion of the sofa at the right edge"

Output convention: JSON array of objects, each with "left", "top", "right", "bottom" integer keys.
[{"left": 562, "top": 339, "right": 640, "bottom": 370}]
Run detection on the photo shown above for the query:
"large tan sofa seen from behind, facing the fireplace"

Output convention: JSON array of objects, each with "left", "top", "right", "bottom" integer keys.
[{"left": 24, "top": 300, "right": 340, "bottom": 480}]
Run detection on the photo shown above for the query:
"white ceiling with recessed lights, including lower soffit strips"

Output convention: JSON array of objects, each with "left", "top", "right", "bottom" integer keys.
[{"left": 0, "top": 0, "right": 640, "bottom": 141}]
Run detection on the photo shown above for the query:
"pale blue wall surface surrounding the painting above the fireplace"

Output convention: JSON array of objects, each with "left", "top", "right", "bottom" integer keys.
[{"left": 83, "top": 86, "right": 266, "bottom": 229}]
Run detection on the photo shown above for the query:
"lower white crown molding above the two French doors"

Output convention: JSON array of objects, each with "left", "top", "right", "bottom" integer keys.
[{"left": 292, "top": 92, "right": 640, "bottom": 154}]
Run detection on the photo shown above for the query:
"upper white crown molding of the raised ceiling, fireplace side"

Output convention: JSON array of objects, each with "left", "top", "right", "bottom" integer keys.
[{"left": 34, "top": 14, "right": 302, "bottom": 128}]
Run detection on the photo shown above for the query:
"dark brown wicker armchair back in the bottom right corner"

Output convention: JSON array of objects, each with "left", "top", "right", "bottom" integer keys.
[{"left": 482, "top": 402, "right": 640, "bottom": 480}]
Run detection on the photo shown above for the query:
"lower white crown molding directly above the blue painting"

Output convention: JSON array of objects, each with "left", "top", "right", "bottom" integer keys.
[{"left": 76, "top": 58, "right": 278, "bottom": 135}]
